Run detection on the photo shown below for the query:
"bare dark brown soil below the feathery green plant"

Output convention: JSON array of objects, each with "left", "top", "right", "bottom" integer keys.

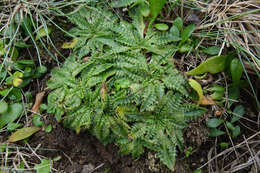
[{"left": 27, "top": 116, "right": 201, "bottom": 173}]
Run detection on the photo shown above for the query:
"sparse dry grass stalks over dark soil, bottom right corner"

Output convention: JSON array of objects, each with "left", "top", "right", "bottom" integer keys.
[{"left": 200, "top": 132, "right": 260, "bottom": 173}]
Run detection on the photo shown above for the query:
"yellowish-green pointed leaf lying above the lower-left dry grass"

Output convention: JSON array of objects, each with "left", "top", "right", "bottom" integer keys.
[{"left": 8, "top": 127, "right": 40, "bottom": 142}]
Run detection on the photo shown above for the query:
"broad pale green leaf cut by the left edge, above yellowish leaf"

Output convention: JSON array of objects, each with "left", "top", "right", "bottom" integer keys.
[{"left": 0, "top": 103, "right": 23, "bottom": 129}]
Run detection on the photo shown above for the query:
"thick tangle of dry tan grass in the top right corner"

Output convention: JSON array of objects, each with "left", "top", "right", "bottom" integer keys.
[{"left": 194, "top": 0, "right": 260, "bottom": 71}]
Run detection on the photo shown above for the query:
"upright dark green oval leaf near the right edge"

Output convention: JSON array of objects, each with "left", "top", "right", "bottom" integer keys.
[{"left": 230, "top": 58, "right": 243, "bottom": 83}]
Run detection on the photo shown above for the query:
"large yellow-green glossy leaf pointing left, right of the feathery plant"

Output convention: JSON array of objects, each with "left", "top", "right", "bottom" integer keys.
[{"left": 187, "top": 56, "right": 228, "bottom": 75}]
